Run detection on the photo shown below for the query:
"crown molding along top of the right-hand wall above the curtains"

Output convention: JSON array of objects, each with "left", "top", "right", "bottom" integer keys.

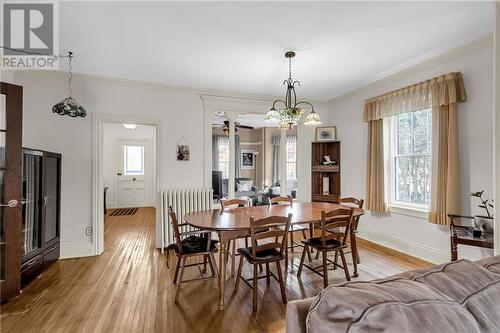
[{"left": 328, "top": 34, "right": 493, "bottom": 103}]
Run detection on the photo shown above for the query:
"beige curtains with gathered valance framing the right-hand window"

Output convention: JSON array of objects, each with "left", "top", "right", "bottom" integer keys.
[{"left": 363, "top": 72, "right": 467, "bottom": 220}]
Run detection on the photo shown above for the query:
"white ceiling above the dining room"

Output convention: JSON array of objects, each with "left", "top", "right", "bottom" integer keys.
[{"left": 59, "top": 1, "right": 492, "bottom": 100}]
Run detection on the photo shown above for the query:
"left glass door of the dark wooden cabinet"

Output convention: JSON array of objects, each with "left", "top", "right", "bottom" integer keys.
[{"left": 21, "top": 154, "right": 42, "bottom": 256}]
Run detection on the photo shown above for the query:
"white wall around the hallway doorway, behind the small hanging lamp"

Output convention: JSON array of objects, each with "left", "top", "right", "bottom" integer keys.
[{"left": 15, "top": 72, "right": 204, "bottom": 257}]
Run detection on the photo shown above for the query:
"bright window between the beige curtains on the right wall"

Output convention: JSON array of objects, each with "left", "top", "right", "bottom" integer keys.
[{"left": 388, "top": 109, "right": 432, "bottom": 209}]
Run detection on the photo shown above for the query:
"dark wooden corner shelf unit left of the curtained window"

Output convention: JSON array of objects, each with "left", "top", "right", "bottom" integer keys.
[{"left": 311, "top": 141, "right": 341, "bottom": 202}]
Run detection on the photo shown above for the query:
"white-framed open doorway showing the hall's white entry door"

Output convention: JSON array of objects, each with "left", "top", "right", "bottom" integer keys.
[{"left": 92, "top": 114, "right": 161, "bottom": 255}]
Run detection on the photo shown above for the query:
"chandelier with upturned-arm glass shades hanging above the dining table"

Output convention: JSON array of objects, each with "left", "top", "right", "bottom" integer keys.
[{"left": 265, "top": 51, "right": 321, "bottom": 131}]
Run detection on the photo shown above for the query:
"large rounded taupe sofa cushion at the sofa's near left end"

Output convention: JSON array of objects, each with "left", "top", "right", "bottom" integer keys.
[{"left": 306, "top": 279, "right": 479, "bottom": 333}]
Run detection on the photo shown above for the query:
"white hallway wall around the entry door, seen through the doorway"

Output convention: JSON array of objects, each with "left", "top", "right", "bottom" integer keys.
[{"left": 102, "top": 123, "right": 156, "bottom": 208}]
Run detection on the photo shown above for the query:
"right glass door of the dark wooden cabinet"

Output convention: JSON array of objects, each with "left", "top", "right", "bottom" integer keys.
[{"left": 44, "top": 156, "right": 59, "bottom": 242}]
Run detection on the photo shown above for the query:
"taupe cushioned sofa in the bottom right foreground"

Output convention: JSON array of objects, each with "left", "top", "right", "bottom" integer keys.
[{"left": 286, "top": 256, "right": 500, "bottom": 333}]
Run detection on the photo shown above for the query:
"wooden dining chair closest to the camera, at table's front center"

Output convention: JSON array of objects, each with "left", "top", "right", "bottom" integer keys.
[{"left": 234, "top": 214, "right": 292, "bottom": 312}]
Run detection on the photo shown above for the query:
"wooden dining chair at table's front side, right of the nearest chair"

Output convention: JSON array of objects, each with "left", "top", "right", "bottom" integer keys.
[{"left": 297, "top": 208, "right": 354, "bottom": 288}]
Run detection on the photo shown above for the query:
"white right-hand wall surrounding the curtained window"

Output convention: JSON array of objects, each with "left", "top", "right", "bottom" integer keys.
[{"left": 329, "top": 42, "right": 493, "bottom": 262}]
